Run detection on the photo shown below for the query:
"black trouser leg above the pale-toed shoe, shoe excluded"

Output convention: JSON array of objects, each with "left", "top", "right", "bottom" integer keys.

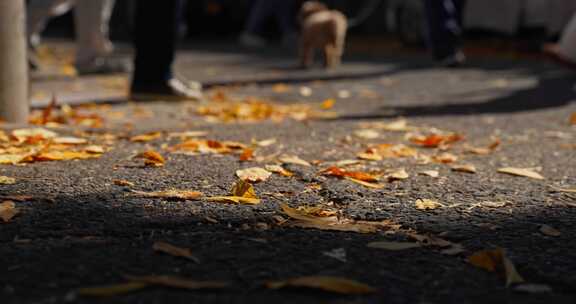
[{"left": 132, "top": 0, "right": 182, "bottom": 88}]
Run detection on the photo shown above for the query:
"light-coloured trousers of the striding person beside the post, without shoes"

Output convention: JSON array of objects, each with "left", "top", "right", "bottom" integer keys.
[{"left": 27, "top": 0, "right": 115, "bottom": 65}]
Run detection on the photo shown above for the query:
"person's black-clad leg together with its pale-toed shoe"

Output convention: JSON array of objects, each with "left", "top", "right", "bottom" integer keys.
[{"left": 131, "top": 0, "right": 202, "bottom": 101}]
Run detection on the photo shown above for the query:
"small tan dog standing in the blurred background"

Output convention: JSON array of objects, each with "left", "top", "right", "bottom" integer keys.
[{"left": 299, "top": 1, "right": 348, "bottom": 68}]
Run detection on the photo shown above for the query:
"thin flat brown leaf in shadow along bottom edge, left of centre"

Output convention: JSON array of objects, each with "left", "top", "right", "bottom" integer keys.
[{"left": 126, "top": 275, "right": 229, "bottom": 290}]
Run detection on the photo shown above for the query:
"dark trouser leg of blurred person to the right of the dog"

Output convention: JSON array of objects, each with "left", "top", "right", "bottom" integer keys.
[{"left": 424, "top": 0, "right": 464, "bottom": 60}]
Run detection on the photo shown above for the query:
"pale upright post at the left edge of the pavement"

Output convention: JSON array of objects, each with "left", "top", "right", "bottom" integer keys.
[{"left": 0, "top": 0, "right": 29, "bottom": 123}]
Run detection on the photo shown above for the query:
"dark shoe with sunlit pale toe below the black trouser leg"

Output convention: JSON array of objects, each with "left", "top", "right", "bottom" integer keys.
[{"left": 130, "top": 78, "right": 203, "bottom": 102}]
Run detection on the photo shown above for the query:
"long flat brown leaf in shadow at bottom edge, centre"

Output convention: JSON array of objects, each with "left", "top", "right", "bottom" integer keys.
[{"left": 266, "top": 276, "right": 377, "bottom": 294}]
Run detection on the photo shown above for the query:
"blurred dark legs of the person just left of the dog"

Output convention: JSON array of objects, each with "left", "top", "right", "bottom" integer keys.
[{"left": 238, "top": 0, "right": 298, "bottom": 48}]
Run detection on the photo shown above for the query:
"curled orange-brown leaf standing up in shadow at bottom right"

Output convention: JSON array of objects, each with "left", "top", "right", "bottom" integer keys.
[{"left": 468, "top": 248, "right": 524, "bottom": 287}]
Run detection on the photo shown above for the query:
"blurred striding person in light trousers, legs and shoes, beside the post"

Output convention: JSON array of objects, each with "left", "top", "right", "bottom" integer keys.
[{"left": 27, "top": 0, "right": 129, "bottom": 74}]
